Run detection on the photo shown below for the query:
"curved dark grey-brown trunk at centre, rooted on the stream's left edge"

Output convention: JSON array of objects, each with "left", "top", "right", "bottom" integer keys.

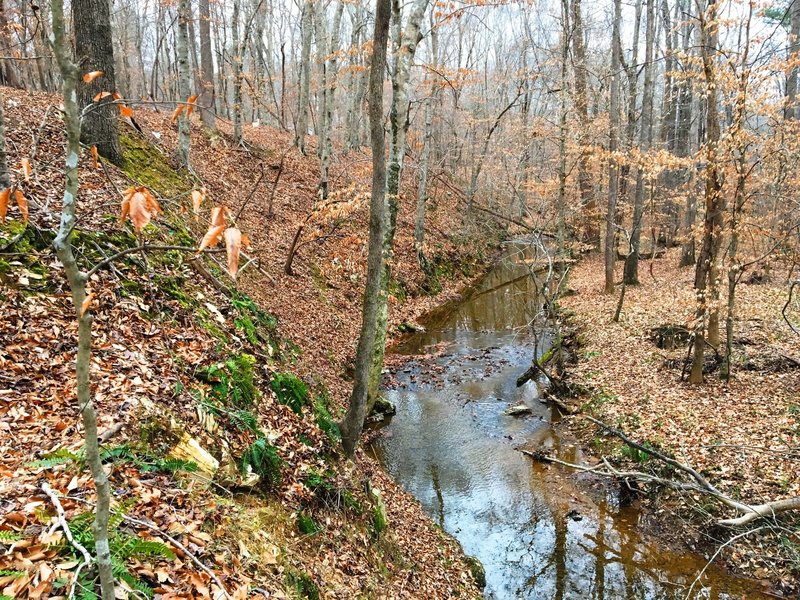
[{"left": 340, "top": 0, "right": 391, "bottom": 458}]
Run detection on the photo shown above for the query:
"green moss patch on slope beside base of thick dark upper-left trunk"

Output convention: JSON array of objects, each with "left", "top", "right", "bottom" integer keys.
[{"left": 120, "top": 134, "right": 192, "bottom": 196}]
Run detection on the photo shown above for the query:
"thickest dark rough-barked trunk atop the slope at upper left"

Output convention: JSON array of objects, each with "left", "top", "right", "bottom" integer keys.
[{"left": 72, "top": 0, "right": 122, "bottom": 164}]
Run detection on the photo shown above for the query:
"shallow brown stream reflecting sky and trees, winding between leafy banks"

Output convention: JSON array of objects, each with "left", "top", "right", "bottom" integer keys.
[{"left": 372, "top": 248, "right": 767, "bottom": 600}]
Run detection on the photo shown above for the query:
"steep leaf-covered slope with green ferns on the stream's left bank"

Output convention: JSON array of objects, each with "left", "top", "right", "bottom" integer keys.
[{"left": 0, "top": 88, "right": 494, "bottom": 600}]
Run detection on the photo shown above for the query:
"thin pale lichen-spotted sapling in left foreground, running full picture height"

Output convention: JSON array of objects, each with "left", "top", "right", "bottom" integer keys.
[{"left": 52, "top": 0, "right": 114, "bottom": 600}]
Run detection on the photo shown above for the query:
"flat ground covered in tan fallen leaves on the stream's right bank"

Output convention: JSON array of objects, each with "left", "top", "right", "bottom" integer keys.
[{"left": 561, "top": 250, "right": 800, "bottom": 597}]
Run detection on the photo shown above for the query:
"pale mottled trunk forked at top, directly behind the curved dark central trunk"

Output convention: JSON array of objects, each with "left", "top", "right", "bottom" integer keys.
[{"left": 367, "top": 0, "right": 430, "bottom": 414}]
